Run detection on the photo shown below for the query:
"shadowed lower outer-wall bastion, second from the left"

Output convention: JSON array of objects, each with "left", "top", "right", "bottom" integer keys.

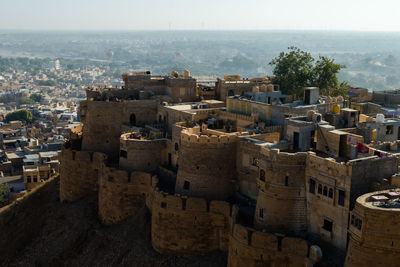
[{"left": 99, "top": 167, "right": 158, "bottom": 224}]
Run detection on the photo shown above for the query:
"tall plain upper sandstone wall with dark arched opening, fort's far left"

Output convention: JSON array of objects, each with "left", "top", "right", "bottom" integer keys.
[{"left": 82, "top": 100, "right": 158, "bottom": 161}]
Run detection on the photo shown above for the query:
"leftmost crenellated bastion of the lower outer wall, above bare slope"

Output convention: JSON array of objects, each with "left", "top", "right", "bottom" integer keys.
[{"left": 59, "top": 148, "right": 107, "bottom": 201}]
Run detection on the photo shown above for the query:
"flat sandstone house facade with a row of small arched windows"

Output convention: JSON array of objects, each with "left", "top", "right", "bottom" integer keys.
[{"left": 306, "top": 152, "right": 351, "bottom": 250}]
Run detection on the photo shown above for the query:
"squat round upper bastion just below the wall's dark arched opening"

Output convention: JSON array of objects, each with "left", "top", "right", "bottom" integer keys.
[{"left": 119, "top": 133, "right": 167, "bottom": 172}]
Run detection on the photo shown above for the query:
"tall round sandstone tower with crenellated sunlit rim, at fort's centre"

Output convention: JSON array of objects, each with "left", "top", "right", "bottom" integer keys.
[{"left": 175, "top": 125, "right": 238, "bottom": 199}]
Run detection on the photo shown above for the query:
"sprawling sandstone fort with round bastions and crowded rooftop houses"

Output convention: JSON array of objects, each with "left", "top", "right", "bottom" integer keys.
[{"left": 0, "top": 70, "right": 400, "bottom": 267}]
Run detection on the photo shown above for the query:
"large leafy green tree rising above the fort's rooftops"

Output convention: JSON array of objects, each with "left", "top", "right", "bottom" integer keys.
[{"left": 269, "top": 46, "right": 348, "bottom": 97}]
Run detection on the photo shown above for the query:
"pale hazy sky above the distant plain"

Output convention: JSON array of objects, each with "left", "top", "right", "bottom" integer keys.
[{"left": 0, "top": 0, "right": 400, "bottom": 31}]
